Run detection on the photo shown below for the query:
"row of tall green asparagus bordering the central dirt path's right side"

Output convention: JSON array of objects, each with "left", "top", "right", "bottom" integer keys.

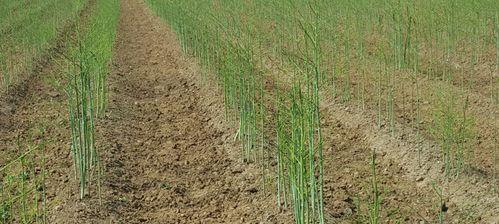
[{"left": 149, "top": 0, "right": 324, "bottom": 223}]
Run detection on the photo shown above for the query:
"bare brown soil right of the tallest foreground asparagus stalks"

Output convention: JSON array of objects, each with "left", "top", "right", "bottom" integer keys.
[{"left": 321, "top": 102, "right": 499, "bottom": 223}]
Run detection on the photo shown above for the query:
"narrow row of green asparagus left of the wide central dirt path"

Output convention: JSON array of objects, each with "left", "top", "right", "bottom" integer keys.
[{"left": 65, "top": 0, "right": 119, "bottom": 198}]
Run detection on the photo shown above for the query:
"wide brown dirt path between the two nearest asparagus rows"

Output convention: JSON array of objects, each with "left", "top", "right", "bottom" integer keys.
[{"left": 58, "top": 0, "right": 292, "bottom": 223}]
